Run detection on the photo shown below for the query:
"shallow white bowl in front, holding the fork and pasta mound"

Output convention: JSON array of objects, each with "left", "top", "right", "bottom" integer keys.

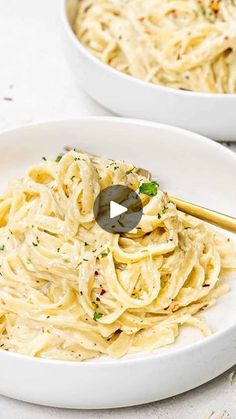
[{"left": 0, "top": 117, "right": 236, "bottom": 409}]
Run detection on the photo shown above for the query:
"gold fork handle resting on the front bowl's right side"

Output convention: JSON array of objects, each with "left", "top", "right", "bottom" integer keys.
[{"left": 169, "top": 196, "right": 236, "bottom": 233}]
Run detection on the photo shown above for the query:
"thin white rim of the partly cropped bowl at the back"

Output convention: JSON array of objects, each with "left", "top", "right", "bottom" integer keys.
[{"left": 60, "top": 0, "right": 236, "bottom": 100}]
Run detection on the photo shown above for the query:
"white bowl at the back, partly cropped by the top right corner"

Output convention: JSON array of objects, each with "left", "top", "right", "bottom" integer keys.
[{"left": 61, "top": 0, "right": 236, "bottom": 141}]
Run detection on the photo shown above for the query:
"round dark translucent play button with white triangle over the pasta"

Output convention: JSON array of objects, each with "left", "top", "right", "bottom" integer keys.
[{"left": 93, "top": 185, "right": 143, "bottom": 233}]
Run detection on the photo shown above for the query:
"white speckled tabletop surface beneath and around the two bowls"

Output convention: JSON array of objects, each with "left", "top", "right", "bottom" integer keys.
[{"left": 0, "top": 0, "right": 236, "bottom": 419}]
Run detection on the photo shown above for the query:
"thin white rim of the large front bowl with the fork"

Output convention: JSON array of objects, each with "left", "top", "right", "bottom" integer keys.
[{"left": 0, "top": 115, "right": 236, "bottom": 368}]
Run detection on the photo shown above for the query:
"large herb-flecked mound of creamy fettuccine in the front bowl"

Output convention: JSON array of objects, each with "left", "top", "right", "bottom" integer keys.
[{"left": 0, "top": 151, "right": 236, "bottom": 361}]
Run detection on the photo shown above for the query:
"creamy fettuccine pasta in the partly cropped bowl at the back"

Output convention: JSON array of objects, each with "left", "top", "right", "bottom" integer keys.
[{"left": 74, "top": 0, "right": 236, "bottom": 93}]
